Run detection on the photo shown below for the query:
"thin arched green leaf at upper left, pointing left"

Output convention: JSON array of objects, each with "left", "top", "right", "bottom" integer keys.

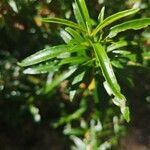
[{"left": 42, "top": 17, "right": 86, "bottom": 32}]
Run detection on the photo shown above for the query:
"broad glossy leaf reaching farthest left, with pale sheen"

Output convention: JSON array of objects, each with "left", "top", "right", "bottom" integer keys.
[{"left": 18, "top": 45, "right": 85, "bottom": 67}]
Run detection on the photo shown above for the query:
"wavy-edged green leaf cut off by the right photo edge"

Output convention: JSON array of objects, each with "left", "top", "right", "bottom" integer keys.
[{"left": 108, "top": 18, "right": 150, "bottom": 38}]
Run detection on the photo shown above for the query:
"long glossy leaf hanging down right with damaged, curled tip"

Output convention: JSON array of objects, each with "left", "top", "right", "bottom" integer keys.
[{"left": 92, "top": 43, "right": 129, "bottom": 121}]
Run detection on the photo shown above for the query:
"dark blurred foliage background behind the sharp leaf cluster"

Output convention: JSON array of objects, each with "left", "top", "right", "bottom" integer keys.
[{"left": 0, "top": 0, "right": 150, "bottom": 150}]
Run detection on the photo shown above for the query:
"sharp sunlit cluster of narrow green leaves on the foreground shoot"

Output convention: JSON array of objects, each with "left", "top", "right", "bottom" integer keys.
[{"left": 18, "top": 0, "right": 150, "bottom": 122}]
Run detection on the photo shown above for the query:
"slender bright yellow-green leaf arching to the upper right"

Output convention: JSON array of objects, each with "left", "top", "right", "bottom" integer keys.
[{"left": 91, "top": 9, "right": 139, "bottom": 36}]
